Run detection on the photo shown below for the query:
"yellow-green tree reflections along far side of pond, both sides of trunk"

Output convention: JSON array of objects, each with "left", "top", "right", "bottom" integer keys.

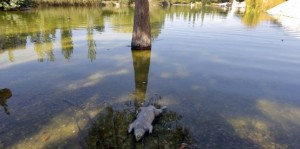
[{"left": 0, "top": 7, "right": 227, "bottom": 62}]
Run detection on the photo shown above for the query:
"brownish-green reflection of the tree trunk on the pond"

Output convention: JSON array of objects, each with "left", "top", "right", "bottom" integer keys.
[{"left": 131, "top": 50, "right": 151, "bottom": 106}]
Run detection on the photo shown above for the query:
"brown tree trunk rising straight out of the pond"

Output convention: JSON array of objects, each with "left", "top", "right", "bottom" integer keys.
[{"left": 131, "top": 0, "right": 151, "bottom": 50}]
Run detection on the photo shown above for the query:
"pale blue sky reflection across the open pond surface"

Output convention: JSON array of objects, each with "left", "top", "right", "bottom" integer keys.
[{"left": 0, "top": 8, "right": 300, "bottom": 148}]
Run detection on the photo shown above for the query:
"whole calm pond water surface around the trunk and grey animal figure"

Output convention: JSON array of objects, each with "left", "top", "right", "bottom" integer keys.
[{"left": 0, "top": 6, "right": 300, "bottom": 149}]
